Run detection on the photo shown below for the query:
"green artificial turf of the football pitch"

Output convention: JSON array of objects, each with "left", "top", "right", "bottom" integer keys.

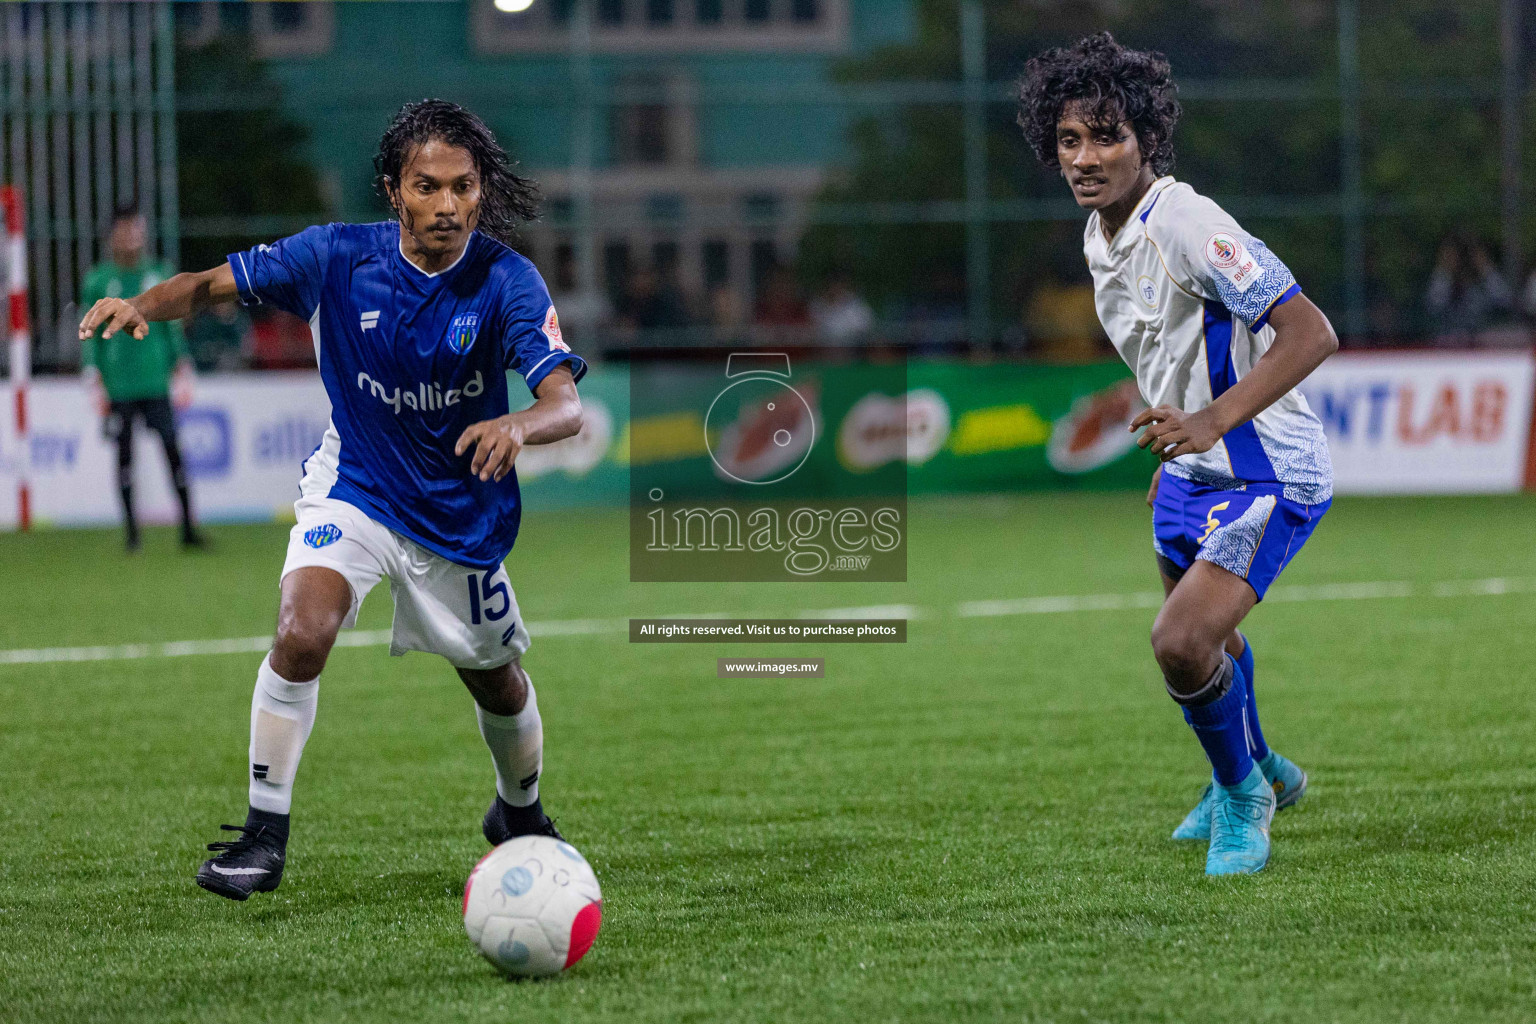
[{"left": 0, "top": 494, "right": 1536, "bottom": 1024}]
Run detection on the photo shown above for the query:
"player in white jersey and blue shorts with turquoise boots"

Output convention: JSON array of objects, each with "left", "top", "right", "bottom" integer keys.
[{"left": 1018, "top": 32, "right": 1338, "bottom": 875}]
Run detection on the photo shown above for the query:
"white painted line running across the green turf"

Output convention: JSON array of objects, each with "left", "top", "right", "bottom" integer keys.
[{"left": 0, "top": 576, "right": 1536, "bottom": 665}]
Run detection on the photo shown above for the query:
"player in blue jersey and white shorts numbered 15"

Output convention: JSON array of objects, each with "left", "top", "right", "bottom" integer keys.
[{"left": 80, "top": 100, "right": 587, "bottom": 900}]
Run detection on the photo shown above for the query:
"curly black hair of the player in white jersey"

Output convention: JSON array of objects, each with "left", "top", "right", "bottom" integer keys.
[{"left": 1018, "top": 32, "right": 1180, "bottom": 175}]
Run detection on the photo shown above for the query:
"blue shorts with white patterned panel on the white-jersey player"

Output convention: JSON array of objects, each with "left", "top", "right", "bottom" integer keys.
[{"left": 1152, "top": 470, "right": 1333, "bottom": 600}]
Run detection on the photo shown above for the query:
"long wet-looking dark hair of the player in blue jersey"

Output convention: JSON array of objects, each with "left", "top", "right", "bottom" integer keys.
[{"left": 373, "top": 100, "right": 539, "bottom": 244}]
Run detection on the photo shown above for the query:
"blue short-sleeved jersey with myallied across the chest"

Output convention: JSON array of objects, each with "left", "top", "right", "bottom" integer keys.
[{"left": 229, "top": 221, "right": 587, "bottom": 570}]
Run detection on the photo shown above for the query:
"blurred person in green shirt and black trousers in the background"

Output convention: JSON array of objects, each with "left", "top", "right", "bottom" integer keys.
[{"left": 80, "top": 206, "right": 203, "bottom": 551}]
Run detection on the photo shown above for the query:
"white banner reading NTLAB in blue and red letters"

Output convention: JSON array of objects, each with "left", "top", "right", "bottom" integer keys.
[{"left": 1301, "top": 352, "right": 1536, "bottom": 494}]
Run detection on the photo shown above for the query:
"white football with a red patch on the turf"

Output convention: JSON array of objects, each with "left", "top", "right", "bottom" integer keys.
[{"left": 464, "top": 835, "right": 602, "bottom": 978}]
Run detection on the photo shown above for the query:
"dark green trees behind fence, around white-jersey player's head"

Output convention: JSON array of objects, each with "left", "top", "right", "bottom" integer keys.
[{"left": 802, "top": 0, "right": 1533, "bottom": 340}]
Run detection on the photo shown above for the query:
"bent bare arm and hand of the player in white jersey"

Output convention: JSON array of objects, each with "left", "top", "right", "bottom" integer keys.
[{"left": 1130, "top": 295, "right": 1339, "bottom": 462}]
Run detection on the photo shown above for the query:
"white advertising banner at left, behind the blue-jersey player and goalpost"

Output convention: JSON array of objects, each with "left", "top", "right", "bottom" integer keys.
[{"left": 0, "top": 372, "right": 330, "bottom": 528}]
